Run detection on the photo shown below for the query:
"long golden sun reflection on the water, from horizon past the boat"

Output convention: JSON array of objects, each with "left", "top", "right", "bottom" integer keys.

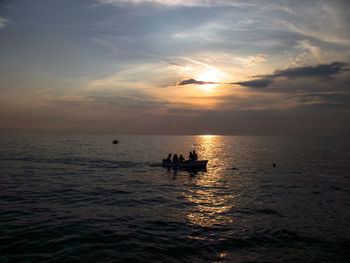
[{"left": 185, "top": 135, "right": 237, "bottom": 227}]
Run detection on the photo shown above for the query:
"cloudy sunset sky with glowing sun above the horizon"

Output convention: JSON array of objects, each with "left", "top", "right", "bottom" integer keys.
[{"left": 0, "top": 0, "right": 350, "bottom": 135}]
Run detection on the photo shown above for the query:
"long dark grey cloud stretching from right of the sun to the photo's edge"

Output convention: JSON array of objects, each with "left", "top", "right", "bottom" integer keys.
[{"left": 235, "top": 62, "right": 348, "bottom": 88}]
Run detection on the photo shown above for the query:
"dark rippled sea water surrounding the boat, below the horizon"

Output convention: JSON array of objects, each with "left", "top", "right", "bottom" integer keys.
[{"left": 0, "top": 136, "right": 350, "bottom": 262}]
